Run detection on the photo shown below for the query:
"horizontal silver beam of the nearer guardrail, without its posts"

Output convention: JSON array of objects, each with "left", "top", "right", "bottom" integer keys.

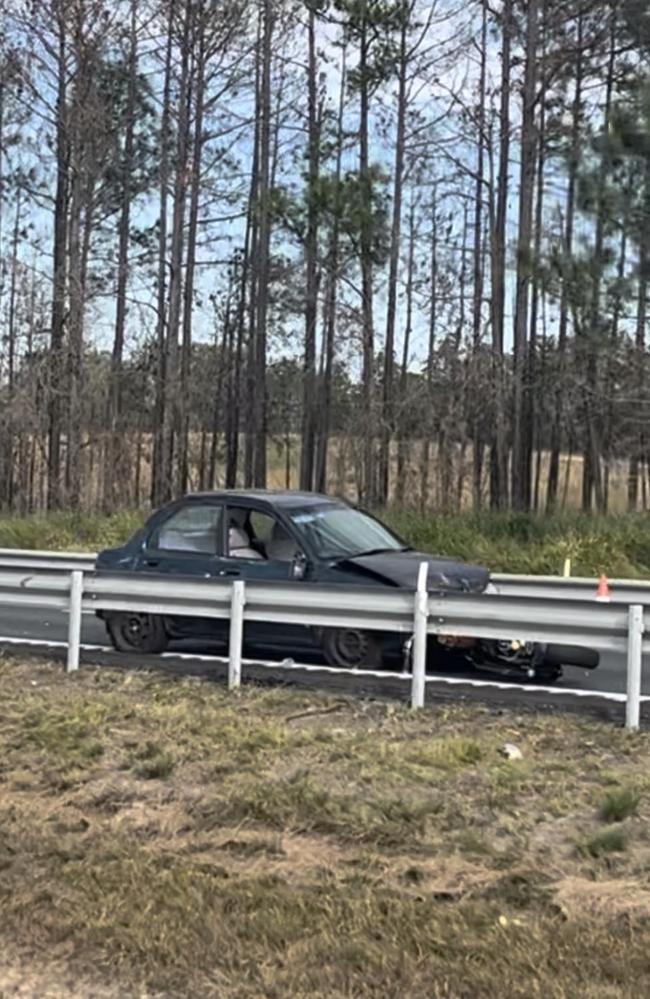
[{"left": 0, "top": 568, "right": 632, "bottom": 653}]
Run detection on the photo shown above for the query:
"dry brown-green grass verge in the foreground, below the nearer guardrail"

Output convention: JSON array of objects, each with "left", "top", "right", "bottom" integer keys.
[{"left": 0, "top": 661, "right": 650, "bottom": 999}]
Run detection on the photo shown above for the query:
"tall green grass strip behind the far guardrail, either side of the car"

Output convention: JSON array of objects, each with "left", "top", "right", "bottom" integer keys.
[{"left": 0, "top": 508, "right": 650, "bottom": 578}]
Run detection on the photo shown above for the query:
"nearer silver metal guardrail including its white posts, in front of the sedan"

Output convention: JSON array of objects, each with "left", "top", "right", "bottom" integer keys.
[{"left": 0, "top": 553, "right": 650, "bottom": 728}]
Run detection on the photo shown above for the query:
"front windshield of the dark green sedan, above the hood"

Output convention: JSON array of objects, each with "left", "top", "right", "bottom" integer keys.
[{"left": 289, "top": 506, "right": 404, "bottom": 558}]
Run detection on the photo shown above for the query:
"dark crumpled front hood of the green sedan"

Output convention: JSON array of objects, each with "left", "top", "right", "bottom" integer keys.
[{"left": 342, "top": 551, "right": 490, "bottom": 593}]
